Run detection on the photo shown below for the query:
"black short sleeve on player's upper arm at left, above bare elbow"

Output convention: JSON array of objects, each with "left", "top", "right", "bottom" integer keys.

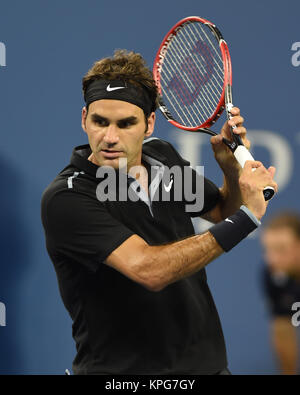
[{"left": 42, "top": 190, "right": 134, "bottom": 271}]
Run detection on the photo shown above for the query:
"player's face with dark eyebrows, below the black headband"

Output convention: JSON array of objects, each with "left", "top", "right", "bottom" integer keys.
[{"left": 82, "top": 100, "right": 155, "bottom": 170}]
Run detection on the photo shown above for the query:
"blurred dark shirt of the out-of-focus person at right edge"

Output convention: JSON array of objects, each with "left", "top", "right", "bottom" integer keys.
[{"left": 262, "top": 263, "right": 300, "bottom": 317}]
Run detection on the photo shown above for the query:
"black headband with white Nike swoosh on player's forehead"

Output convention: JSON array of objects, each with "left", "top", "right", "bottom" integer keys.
[{"left": 84, "top": 80, "right": 155, "bottom": 115}]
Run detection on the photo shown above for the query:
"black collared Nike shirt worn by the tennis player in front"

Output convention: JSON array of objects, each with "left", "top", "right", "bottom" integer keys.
[{"left": 42, "top": 139, "right": 227, "bottom": 374}]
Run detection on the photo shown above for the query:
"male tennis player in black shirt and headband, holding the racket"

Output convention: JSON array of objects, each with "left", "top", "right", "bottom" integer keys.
[{"left": 42, "top": 51, "right": 277, "bottom": 375}]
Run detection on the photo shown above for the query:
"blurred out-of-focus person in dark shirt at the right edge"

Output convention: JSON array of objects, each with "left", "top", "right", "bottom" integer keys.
[{"left": 261, "top": 212, "right": 300, "bottom": 374}]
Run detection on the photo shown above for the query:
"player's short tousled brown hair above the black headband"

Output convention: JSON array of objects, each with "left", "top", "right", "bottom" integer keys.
[{"left": 82, "top": 49, "right": 158, "bottom": 117}]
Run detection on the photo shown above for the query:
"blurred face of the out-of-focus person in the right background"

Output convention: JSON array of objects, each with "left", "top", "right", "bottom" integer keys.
[{"left": 262, "top": 227, "right": 300, "bottom": 274}]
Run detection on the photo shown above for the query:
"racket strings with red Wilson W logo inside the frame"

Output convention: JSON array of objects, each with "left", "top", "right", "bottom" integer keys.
[{"left": 161, "top": 22, "right": 224, "bottom": 127}]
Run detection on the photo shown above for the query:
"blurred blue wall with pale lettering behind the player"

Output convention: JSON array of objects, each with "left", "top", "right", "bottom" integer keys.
[{"left": 0, "top": 0, "right": 300, "bottom": 374}]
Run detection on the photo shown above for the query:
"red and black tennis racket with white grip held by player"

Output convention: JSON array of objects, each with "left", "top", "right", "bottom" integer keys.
[{"left": 153, "top": 16, "right": 275, "bottom": 201}]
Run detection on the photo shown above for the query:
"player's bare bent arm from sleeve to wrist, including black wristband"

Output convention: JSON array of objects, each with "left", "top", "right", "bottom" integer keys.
[{"left": 105, "top": 208, "right": 257, "bottom": 291}]
